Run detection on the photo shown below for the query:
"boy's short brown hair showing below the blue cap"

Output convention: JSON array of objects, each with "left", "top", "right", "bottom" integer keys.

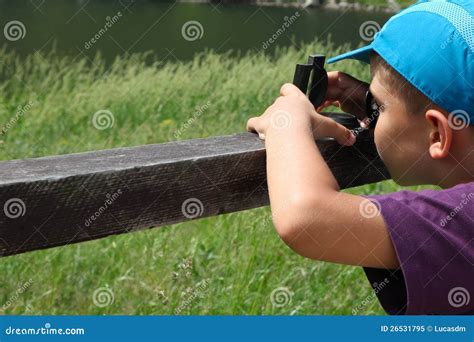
[{"left": 370, "top": 51, "right": 438, "bottom": 114}]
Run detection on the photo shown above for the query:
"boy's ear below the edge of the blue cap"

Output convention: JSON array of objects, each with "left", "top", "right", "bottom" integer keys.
[{"left": 425, "top": 109, "right": 453, "bottom": 159}]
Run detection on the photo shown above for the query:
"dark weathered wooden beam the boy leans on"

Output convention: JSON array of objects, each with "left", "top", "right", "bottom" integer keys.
[{"left": 0, "top": 132, "right": 389, "bottom": 256}]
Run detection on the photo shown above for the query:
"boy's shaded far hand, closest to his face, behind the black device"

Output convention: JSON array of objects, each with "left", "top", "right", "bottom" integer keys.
[{"left": 316, "top": 71, "right": 369, "bottom": 120}]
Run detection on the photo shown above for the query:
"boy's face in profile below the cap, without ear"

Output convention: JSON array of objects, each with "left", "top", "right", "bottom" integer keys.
[{"left": 370, "top": 73, "right": 429, "bottom": 185}]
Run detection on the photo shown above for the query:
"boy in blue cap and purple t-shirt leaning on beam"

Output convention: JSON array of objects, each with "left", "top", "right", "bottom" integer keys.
[{"left": 247, "top": 0, "right": 474, "bottom": 314}]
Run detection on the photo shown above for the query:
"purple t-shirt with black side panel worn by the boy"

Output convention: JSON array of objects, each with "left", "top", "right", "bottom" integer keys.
[{"left": 364, "top": 182, "right": 474, "bottom": 315}]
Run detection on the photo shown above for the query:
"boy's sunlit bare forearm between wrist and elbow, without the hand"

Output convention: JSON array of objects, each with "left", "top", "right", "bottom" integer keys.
[{"left": 265, "top": 123, "right": 339, "bottom": 240}]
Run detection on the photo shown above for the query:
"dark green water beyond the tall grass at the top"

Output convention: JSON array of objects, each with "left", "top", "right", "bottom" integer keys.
[{"left": 0, "top": 0, "right": 390, "bottom": 61}]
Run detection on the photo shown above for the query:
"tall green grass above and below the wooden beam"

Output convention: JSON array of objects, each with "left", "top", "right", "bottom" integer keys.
[{"left": 0, "top": 40, "right": 430, "bottom": 315}]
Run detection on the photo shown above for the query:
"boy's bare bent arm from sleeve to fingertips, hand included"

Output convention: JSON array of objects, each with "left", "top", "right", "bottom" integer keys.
[{"left": 248, "top": 84, "right": 399, "bottom": 268}]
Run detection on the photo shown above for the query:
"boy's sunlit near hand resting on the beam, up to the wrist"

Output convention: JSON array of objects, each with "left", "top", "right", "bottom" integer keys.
[{"left": 247, "top": 83, "right": 355, "bottom": 145}]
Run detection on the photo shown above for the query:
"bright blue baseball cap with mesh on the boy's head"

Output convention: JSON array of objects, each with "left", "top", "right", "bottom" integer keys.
[{"left": 327, "top": 0, "right": 474, "bottom": 125}]
